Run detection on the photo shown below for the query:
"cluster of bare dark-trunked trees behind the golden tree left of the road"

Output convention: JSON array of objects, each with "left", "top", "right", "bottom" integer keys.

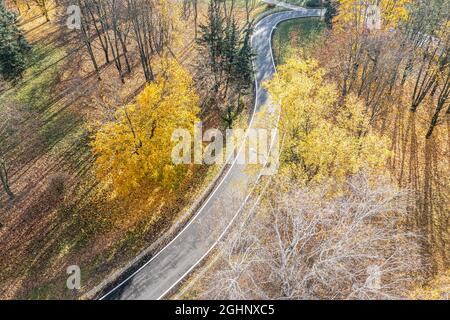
[{"left": 67, "top": 0, "right": 178, "bottom": 83}]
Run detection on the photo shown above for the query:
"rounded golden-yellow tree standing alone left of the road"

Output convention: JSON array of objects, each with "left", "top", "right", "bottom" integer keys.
[{"left": 92, "top": 60, "right": 199, "bottom": 196}]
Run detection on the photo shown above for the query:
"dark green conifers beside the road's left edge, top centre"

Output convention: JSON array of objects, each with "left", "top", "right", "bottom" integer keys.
[{"left": 197, "top": 0, "right": 253, "bottom": 127}]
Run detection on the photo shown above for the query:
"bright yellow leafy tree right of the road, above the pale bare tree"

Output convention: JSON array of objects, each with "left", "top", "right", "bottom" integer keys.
[{"left": 266, "top": 58, "right": 389, "bottom": 183}]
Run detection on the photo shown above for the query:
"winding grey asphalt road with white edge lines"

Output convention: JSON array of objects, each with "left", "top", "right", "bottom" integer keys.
[{"left": 101, "top": 8, "right": 323, "bottom": 300}]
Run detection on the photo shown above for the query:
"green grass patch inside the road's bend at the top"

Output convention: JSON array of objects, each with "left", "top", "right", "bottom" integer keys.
[{"left": 272, "top": 18, "right": 326, "bottom": 64}]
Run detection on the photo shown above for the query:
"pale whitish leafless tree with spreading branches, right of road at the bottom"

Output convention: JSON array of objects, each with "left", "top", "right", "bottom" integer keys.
[{"left": 204, "top": 174, "right": 421, "bottom": 299}]
